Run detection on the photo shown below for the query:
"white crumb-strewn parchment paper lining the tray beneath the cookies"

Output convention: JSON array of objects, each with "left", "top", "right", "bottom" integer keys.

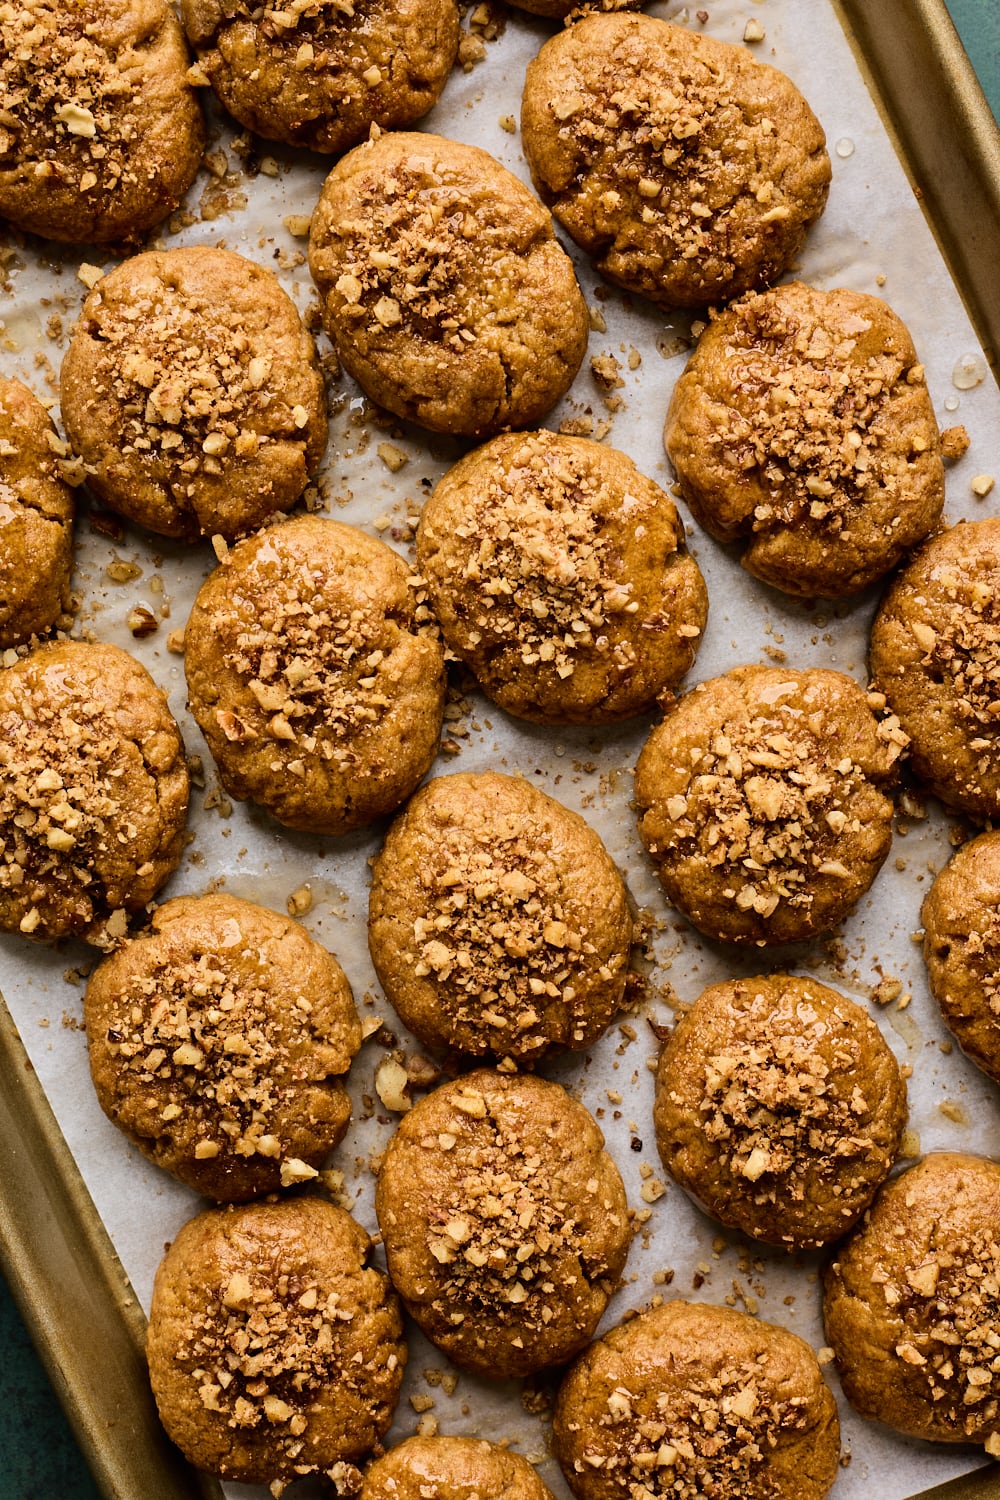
[{"left": 0, "top": 0, "right": 1000, "bottom": 1500}]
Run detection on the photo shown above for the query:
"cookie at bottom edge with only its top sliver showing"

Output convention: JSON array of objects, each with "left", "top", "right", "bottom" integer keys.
[{"left": 360, "top": 1436, "right": 553, "bottom": 1500}]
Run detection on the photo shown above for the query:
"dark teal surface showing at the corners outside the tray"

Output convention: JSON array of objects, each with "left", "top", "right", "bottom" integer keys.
[{"left": 0, "top": 0, "right": 1000, "bottom": 1500}]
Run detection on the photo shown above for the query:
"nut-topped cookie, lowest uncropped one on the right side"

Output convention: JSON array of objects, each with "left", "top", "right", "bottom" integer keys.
[{"left": 654, "top": 974, "right": 907, "bottom": 1250}]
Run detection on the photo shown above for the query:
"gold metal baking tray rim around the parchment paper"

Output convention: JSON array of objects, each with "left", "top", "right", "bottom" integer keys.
[{"left": 0, "top": 0, "right": 1000, "bottom": 1500}]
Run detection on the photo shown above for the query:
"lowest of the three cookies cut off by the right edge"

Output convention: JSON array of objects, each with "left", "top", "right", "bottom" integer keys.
[{"left": 823, "top": 1152, "right": 1000, "bottom": 1454}]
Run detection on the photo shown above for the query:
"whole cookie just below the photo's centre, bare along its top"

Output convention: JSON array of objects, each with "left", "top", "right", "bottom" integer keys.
[{"left": 369, "top": 771, "right": 633, "bottom": 1065}]
